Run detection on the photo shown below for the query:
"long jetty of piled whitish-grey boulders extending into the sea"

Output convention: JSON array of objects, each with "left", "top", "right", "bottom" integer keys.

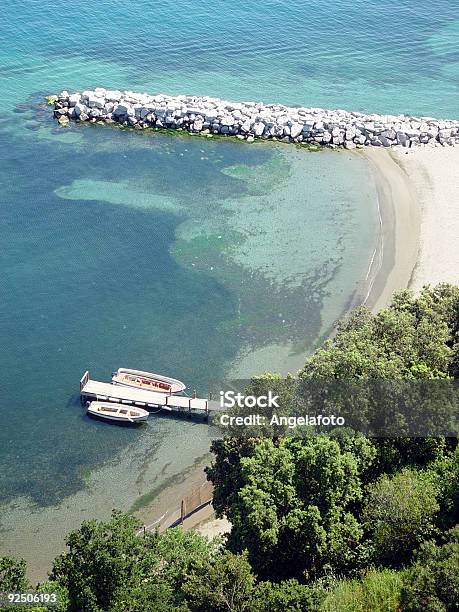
[{"left": 48, "top": 87, "right": 459, "bottom": 149}]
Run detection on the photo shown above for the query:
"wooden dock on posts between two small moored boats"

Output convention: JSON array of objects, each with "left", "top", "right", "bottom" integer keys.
[{"left": 80, "top": 371, "right": 215, "bottom": 415}]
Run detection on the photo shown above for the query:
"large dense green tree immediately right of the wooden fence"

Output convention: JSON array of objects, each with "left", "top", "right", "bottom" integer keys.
[{"left": 210, "top": 436, "right": 372, "bottom": 580}]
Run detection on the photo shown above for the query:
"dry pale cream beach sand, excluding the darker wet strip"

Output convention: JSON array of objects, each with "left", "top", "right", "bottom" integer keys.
[{"left": 393, "top": 147, "right": 459, "bottom": 290}]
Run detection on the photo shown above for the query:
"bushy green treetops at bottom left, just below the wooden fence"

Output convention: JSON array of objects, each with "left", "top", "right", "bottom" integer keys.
[{"left": 51, "top": 512, "right": 216, "bottom": 612}]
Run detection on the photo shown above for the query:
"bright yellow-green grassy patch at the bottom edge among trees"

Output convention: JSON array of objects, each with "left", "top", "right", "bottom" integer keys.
[{"left": 320, "top": 569, "right": 403, "bottom": 612}]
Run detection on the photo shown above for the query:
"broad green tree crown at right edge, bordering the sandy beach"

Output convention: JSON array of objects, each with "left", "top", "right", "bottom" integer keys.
[{"left": 299, "top": 285, "right": 459, "bottom": 444}]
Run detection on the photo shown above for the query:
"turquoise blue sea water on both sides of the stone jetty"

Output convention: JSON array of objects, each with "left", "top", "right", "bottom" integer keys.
[{"left": 0, "top": 0, "right": 459, "bottom": 572}]
